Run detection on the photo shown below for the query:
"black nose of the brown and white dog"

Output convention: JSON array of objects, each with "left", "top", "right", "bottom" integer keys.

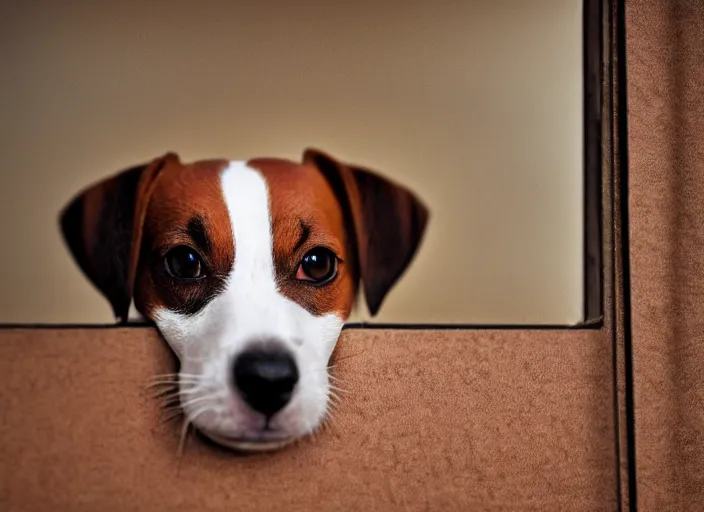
[{"left": 233, "top": 349, "right": 298, "bottom": 417}]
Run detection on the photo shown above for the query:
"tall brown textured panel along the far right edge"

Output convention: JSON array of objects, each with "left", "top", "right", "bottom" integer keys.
[{"left": 627, "top": 0, "right": 704, "bottom": 511}]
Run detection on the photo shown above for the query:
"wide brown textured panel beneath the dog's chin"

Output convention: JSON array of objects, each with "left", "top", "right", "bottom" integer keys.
[{"left": 0, "top": 328, "right": 617, "bottom": 512}]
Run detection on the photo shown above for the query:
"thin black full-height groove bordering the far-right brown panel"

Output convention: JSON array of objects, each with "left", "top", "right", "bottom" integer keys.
[{"left": 613, "top": 0, "right": 638, "bottom": 511}]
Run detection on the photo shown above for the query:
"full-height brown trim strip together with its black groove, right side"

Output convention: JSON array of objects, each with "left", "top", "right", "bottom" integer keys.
[{"left": 596, "top": 0, "right": 637, "bottom": 511}]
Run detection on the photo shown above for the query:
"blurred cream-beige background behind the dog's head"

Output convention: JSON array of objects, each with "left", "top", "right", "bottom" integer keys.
[{"left": 0, "top": 0, "right": 582, "bottom": 323}]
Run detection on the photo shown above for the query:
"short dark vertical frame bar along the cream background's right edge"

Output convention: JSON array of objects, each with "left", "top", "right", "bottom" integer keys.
[{"left": 582, "top": 0, "right": 604, "bottom": 322}]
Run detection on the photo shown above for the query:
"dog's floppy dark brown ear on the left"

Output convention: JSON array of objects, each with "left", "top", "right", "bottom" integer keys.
[{"left": 59, "top": 153, "right": 179, "bottom": 323}]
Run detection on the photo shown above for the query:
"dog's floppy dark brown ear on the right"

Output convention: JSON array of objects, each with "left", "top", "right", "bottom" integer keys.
[{"left": 303, "top": 148, "right": 428, "bottom": 315}]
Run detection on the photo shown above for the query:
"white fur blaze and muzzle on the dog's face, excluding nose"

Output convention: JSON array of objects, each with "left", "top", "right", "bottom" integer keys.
[{"left": 154, "top": 162, "right": 343, "bottom": 449}]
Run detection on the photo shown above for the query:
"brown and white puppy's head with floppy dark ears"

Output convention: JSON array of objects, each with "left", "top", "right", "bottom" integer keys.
[{"left": 59, "top": 148, "right": 429, "bottom": 451}]
